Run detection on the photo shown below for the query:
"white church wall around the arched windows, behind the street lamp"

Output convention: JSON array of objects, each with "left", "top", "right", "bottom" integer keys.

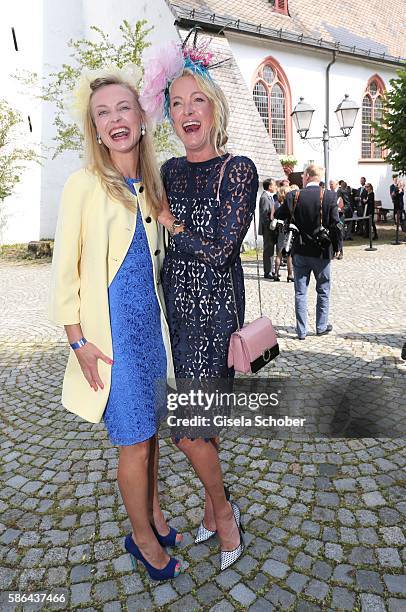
[{"left": 227, "top": 34, "right": 395, "bottom": 208}]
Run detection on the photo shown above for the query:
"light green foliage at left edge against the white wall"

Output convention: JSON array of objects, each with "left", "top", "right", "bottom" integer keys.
[{"left": 0, "top": 99, "right": 40, "bottom": 204}]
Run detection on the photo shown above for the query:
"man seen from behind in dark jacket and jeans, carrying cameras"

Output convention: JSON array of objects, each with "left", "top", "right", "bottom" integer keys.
[{"left": 276, "top": 164, "right": 341, "bottom": 340}]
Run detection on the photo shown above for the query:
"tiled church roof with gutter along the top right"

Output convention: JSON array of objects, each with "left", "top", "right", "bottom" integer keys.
[{"left": 168, "top": 0, "right": 406, "bottom": 63}]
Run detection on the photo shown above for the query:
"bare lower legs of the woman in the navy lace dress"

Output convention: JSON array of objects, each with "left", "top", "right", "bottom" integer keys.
[{"left": 177, "top": 438, "right": 240, "bottom": 550}]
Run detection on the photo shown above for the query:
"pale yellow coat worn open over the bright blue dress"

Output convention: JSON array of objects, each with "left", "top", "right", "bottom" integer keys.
[{"left": 49, "top": 169, "right": 174, "bottom": 423}]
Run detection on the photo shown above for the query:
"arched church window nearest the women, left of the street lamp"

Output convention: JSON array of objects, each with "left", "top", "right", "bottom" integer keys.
[{"left": 252, "top": 58, "right": 292, "bottom": 155}]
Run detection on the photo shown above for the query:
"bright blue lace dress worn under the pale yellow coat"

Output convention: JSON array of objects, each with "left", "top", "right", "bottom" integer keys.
[{"left": 103, "top": 179, "right": 166, "bottom": 446}]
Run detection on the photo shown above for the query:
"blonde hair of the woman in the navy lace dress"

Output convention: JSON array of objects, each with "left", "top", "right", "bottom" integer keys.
[{"left": 169, "top": 68, "right": 230, "bottom": 154}]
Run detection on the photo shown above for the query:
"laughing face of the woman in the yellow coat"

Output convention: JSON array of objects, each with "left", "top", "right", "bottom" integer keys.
[{"left": 90, "top": 85, "right": 141, "bottom": 153}]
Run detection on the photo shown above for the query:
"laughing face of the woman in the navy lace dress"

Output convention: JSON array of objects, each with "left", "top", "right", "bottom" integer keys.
[{"left": 170, "top": 75, "right": 215, "bottom": 157}]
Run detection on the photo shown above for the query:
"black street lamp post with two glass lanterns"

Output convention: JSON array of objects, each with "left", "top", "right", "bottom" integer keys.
[{"left": 291, "top": 94, "right": 359, "bottom": 185}]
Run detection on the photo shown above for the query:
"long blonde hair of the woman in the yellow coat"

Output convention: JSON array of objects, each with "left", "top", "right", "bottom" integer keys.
[{"left": 84, "top": 75, "right": 163, "bottom": 218}]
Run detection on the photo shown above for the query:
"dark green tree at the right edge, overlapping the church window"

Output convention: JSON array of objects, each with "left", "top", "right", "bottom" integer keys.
[{"left": 372, "top": 67, "right": 406, "bottom": 174}]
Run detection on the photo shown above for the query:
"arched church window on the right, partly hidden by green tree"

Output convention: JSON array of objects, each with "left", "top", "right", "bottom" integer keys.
[{"left": 361, "top": 74, "right": 385, "bottom": 159}]
